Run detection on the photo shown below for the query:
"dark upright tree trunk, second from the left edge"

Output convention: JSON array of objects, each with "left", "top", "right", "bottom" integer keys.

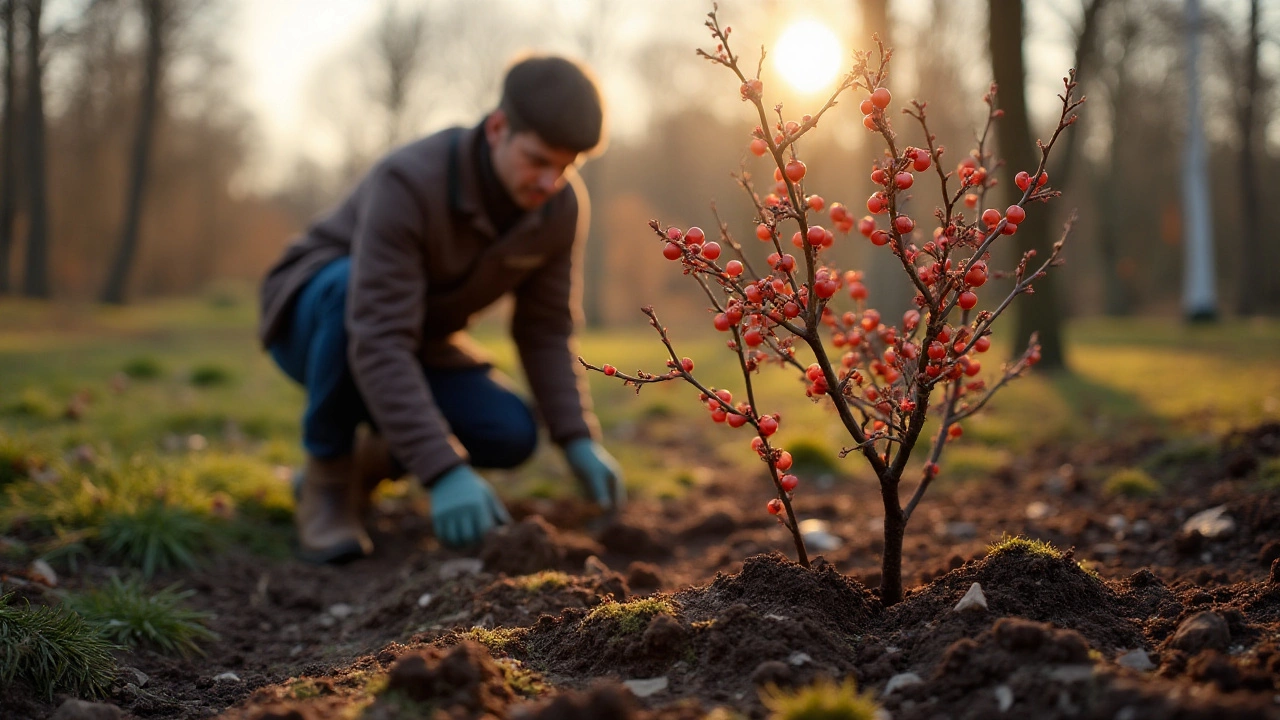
[{"left": 22, "top": 0, "right": 51, "bottom": 297}]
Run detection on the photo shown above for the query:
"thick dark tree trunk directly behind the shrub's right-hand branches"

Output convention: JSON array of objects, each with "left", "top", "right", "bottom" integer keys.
[{"left": 987, "top": 0, "right": 1066, "bottom": 370}]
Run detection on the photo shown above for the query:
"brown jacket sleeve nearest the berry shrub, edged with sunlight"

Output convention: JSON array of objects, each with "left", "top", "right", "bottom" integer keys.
[{"left": 511, "top": 183, "right": 600, "bottom": 445}]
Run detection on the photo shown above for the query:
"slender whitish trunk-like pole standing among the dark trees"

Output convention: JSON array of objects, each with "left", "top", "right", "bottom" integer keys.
[{"left": 1183, "top": 0, "right": 1217, "bottom": 320}]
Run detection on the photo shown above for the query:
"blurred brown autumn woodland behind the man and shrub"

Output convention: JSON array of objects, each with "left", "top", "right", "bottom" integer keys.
[{"left": 0, "top": 0, "right": 1280, "bottom": 324}]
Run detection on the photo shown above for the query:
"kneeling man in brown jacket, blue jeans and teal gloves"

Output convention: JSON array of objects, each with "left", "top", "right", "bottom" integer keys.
[{"left": 260, "top": 56, "right": 623, "bottom": 562}]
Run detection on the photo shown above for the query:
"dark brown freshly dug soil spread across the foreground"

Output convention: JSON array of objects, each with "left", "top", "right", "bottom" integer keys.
[{"left": 0, "top": 424, "right": 1280, "bottom": 720}]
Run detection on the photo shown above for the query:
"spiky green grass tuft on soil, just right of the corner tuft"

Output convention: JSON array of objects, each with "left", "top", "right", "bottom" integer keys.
[{"left": 69, "top": 575, "right": 218, "bottom": 656}]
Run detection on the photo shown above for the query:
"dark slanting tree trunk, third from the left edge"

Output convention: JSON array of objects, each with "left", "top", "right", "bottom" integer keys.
[{"left": 102, "top": 0, "right": 165, "bottom": 305}]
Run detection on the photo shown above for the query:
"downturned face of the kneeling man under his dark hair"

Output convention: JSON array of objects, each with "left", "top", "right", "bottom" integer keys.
[{"left": 484, "top": 110, "right": 577, "bottom": 210}]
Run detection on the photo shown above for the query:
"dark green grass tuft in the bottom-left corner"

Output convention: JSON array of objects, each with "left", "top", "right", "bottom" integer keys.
[{"left": 0, "top": 594, "right": 115, "bottom": 700}]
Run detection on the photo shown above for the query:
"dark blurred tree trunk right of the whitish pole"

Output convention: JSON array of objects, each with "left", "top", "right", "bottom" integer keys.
[{"left": 1238, "top": 0, "right": 1267, "bottom": 315}]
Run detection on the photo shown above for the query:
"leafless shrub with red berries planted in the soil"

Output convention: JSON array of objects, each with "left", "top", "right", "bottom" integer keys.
[{"left": 580, "top": 10, "right": 1080, "bottom": 605}]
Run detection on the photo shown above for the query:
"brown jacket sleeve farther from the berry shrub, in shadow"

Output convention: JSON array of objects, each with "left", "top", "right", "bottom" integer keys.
[{"left": 347, "top": 168, "right": 467, "bottom": 484}]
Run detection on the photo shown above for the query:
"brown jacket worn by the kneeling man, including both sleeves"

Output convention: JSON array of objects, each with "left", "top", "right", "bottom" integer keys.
[{"left": 259, "top": 127, "right": 598, "bottom": 482}]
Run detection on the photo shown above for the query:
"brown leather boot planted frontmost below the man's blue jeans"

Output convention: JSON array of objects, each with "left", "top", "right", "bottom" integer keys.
[{"left": 293, "top": 455, "right": 374, "bottom": 565}]
